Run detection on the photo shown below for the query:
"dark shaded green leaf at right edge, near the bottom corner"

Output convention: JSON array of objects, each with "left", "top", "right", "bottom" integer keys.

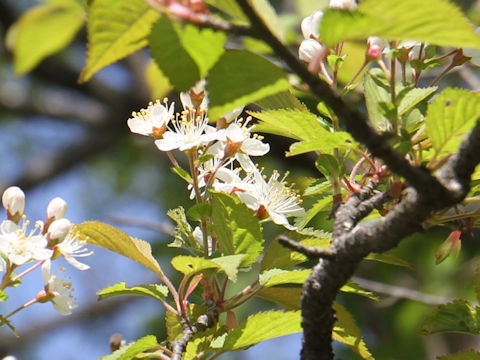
[{"left": 419, "top": 300, "right": 480, "bottom": 336}]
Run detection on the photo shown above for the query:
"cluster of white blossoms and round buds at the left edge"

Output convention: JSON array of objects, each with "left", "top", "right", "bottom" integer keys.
[{"left": 0, "top": 186, "right": 92, "bottom": 315}]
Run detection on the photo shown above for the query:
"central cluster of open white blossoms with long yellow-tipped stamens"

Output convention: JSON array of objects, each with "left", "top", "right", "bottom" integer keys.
[{"left": 128, "top": 82, "right": 304, "bottom": 229}]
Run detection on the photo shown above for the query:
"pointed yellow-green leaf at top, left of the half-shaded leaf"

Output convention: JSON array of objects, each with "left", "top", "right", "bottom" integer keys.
[{"left": 79, "top": 0, "right": 160, "bottom": 82}]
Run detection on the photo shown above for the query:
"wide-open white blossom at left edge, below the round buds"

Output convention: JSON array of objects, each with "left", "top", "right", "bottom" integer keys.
[{"left": 0, "top": 220, "right": 53, "bottom": 265}]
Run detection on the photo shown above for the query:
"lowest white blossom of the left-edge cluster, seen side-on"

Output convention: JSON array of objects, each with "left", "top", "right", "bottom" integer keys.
[{"left": 42, "top": 260, "right": 77, "bottom": 315}]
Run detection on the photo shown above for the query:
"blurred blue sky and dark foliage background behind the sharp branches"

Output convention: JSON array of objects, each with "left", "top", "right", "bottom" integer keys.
[{"left": 0, "top": 0, "right": 480, "bottom": 360}]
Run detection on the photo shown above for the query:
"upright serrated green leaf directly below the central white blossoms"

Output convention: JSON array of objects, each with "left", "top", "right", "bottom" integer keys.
[{"left": 212, "top": 193, "right": 264, "bottom": 267}]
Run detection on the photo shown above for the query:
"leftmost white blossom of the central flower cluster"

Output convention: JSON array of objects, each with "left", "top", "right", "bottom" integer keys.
[{"left": 127, "top": 99, "right": 175, "bottom": 139}]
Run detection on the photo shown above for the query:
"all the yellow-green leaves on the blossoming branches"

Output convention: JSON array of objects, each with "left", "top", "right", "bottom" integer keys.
[{"left": 9, "top": 0, "right": 480, "bottom": 360}]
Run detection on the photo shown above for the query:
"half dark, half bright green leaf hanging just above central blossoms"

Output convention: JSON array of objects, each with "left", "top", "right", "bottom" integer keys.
[{"left": 149, "top": 18, "right": 226, "bottom": 91}]
